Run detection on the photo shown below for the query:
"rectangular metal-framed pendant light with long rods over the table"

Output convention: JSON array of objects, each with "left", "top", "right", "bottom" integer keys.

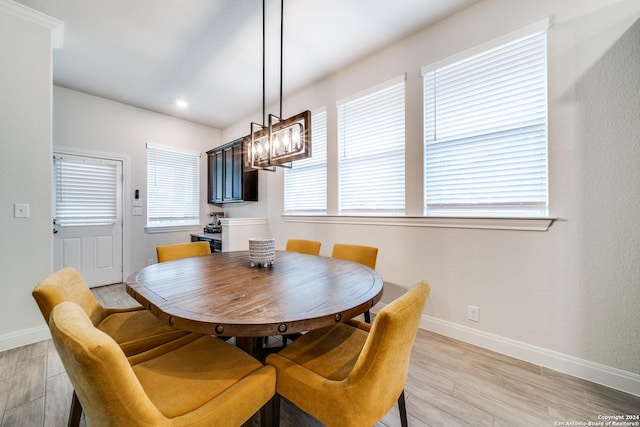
[{"left": 247, "top": 0, "right": 311, "bottom": 171}]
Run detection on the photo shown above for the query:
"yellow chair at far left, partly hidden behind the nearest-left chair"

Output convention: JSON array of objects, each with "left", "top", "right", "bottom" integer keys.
[{"left": 32, "top": 267, "right": 188, "bottom": 426}]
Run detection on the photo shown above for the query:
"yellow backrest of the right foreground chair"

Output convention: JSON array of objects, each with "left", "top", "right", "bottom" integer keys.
[{"left": 348, "top": 280, "right": 430, "bottom": 417}]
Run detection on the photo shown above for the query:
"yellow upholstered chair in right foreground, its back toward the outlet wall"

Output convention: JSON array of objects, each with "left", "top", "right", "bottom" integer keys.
[{"left": 266, "top": 281, "right": 430, "bottom": 427}]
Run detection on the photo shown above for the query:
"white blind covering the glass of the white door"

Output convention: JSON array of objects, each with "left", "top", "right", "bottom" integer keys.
[{"left": 53, "top": 155, "right": 121, "bottom": 226}]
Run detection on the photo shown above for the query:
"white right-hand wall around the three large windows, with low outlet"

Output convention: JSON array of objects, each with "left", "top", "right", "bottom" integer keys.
[{"left": 224, "top": 0, "right": 640, "bottom": 394}]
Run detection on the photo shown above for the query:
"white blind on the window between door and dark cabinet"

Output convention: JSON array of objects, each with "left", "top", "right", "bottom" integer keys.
[{"left": 147, "top": 145, "right": 200, "bottom": 227}]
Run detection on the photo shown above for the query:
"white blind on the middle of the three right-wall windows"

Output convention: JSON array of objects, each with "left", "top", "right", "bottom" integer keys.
[{"left": 338, "top": 76, "right": 405, "bottom": 215}]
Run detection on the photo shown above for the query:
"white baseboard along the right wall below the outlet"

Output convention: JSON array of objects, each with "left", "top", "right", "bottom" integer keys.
[{"left": 371, "top": 303, "right": 640, "bottom": 396}]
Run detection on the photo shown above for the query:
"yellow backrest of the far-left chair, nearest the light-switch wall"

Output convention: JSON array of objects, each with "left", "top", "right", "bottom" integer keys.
[{"left": 32, "top": 267, "right": 107, "bottom": 326}]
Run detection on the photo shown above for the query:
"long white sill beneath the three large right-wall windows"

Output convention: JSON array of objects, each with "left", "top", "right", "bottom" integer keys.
[{"left": 282, "top": 214, "right": 556, "bottom": 231}]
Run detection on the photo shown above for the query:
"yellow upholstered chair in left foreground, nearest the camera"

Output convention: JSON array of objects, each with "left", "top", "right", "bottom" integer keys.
[{"left": 49, "top": 302, "right": 275, "bottom": 427}]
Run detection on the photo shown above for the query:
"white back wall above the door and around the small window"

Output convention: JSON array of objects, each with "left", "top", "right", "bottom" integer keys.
[{"left": 53, "top": 86, "right": 221, "bottom": 279}]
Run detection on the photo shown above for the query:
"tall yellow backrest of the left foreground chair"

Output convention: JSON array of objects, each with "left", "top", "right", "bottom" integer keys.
[{"left": 49, "top": 302, "right": 166, "bottom": 426}]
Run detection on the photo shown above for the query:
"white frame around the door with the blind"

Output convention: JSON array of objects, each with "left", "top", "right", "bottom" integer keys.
[{"left": 51, "top": 145, "right": 131, "bottom": 281}]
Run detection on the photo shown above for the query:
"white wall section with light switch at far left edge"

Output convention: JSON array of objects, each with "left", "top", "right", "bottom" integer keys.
[{"left": 0, "top": 4, "right": 53, "bottom": 350}]
